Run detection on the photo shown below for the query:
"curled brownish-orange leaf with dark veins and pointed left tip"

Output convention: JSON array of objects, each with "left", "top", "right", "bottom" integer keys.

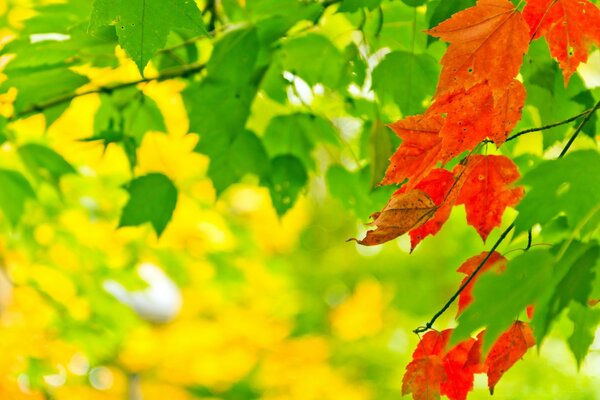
[{"left": 350, "top": 189, "right": 438, "bottom": 246}]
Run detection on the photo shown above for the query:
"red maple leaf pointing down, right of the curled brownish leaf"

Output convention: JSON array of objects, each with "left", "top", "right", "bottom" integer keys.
[{"left": 454, "top": 155, "right": 524, "bottom": 241}]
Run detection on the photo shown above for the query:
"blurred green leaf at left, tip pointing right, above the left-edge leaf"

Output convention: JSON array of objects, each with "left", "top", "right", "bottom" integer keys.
[{"left": 18, "top": 143, "right": 76, "bottom": 185}]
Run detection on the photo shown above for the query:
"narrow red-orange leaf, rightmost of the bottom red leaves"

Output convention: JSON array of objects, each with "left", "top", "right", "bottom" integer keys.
[{"left": 485, "top": 321, "right": 535, "bottom": 394}]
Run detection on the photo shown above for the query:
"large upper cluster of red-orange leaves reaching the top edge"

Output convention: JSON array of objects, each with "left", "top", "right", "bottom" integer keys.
[{"left": 358, "top": 0, "right": 600, "bottom": 249}]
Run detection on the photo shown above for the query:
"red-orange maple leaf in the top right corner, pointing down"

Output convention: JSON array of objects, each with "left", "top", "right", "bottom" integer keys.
[{"left": 523, "top": 0, "right": 600, "bottom": 86}]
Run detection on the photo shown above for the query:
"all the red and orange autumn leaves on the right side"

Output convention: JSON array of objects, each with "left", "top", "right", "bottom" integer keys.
[{"left": 358, "top": 0, "right": 600, "bottom": 400}]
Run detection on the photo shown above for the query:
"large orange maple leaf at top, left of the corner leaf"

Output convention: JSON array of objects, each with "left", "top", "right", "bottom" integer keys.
[{"left": 427, "top": 0, "right": 529, "bottom": 95}]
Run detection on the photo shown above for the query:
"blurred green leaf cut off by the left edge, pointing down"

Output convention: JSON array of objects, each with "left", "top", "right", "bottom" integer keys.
[{"left": 0, "top": 169, "right": 35, "bottom": 227}]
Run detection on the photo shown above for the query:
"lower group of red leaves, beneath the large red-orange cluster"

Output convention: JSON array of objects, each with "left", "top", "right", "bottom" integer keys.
[{"left": 402, "top": 252, "right": 535, "bottom": 400}]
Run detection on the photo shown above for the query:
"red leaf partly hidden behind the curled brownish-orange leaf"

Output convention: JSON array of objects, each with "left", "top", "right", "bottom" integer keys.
[{"left": 400, "top": 168, "right": 456, "bottom": 251}]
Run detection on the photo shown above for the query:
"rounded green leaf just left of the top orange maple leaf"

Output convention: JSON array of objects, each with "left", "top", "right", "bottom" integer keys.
[{"left": 373, "top": 51, "right": 440, "bottom": 115}]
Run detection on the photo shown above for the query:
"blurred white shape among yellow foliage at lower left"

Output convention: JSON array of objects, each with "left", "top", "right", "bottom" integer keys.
[{"left": 103, "top": 263, "right": 182, "bottom": 323}]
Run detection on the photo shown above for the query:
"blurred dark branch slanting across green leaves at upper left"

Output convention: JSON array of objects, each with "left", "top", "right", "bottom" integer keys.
[{"left": 8, "top": 64, "right": 206, "bottom": 122}]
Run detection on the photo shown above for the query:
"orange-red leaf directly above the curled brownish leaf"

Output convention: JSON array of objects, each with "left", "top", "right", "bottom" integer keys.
[{"left": 381, "top": 114, "right": 444, "bottom": 190}]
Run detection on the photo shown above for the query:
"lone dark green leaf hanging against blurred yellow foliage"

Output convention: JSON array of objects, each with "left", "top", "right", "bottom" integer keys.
[{"left": 119, "top": 173, "right": 177, "bottom": 236}]
